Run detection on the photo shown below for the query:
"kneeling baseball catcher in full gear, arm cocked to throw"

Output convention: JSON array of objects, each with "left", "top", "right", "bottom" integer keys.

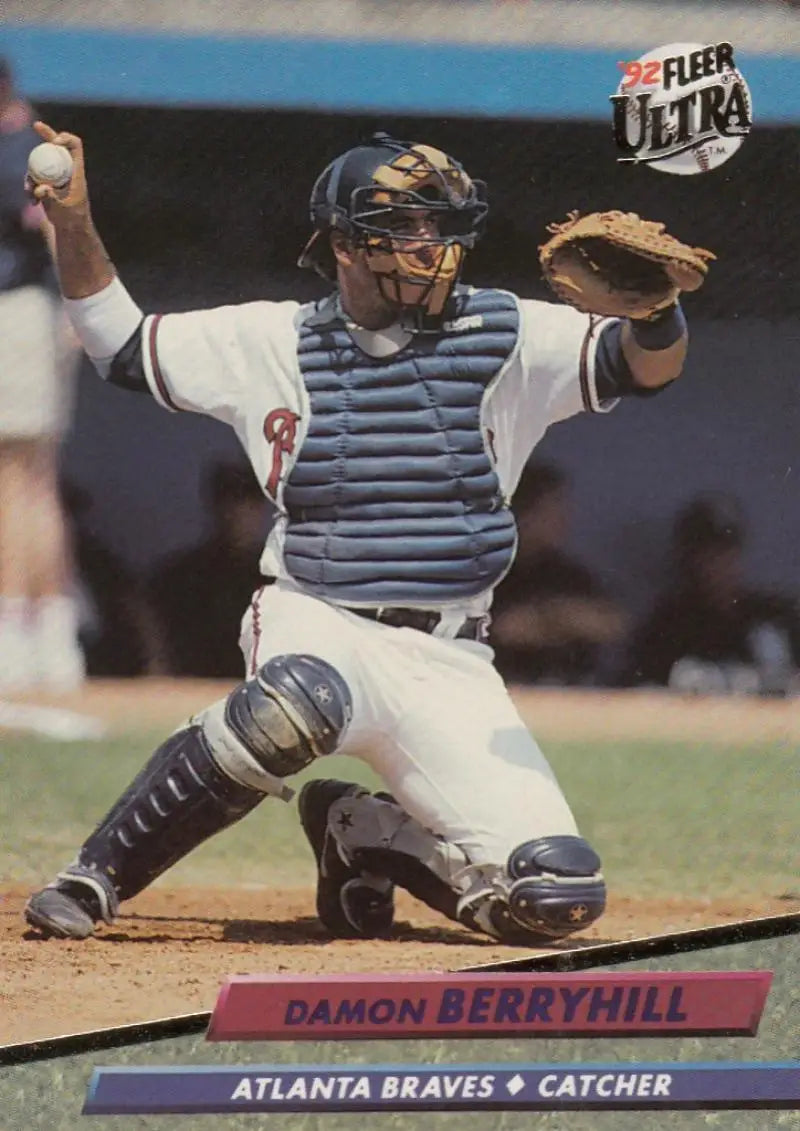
[{"left": 26, "top": 124, "right": 709, "bottom": 943}]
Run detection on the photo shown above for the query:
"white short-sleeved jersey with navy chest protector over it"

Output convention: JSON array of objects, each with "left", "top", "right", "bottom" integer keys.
[{"left": 132, "top": 287, "right": 616, "bottom": 615}]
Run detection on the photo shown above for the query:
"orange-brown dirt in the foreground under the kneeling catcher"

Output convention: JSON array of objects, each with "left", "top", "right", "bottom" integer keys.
[{"left": 0, "top": 888, "right": 800, "bottom": 1045}]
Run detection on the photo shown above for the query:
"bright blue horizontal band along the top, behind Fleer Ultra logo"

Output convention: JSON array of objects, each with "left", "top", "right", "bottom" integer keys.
[{"left": 0, "top": 24, "right": 800, "bottom": 124}]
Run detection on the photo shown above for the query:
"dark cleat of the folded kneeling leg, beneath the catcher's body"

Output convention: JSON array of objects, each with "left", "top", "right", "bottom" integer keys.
[{"left": 298, "top": 778, "right": 395, "bottom": 939}]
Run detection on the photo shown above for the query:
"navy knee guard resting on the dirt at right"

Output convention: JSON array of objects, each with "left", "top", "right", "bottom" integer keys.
[{"left": 506, "top": 836, "right": 605, "bottom": 939}]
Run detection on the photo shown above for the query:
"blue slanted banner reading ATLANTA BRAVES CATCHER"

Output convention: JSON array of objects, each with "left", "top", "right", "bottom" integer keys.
[{"left": 83, "top": 1062, "right": 800, "bottom": 1115}]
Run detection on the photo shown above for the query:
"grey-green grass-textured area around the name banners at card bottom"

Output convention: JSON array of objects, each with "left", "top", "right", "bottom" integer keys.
[{"left": 0, "top": 935, "right": 800, "bottom": 1131}]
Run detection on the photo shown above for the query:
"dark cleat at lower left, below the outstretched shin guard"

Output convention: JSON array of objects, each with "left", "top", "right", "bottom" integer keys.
[{"left": 25, "top": 866, "right": 119, "bottom": 939}]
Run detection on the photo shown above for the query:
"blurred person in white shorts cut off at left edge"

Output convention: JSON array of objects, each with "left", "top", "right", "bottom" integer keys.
[{"left": 0, "top": 59, "right": 84, "bottom": 692}]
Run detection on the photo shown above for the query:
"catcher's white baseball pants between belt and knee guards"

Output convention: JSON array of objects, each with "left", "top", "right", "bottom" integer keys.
[{"left": 241, "top": 585, "right": 577, "bottom": 866}]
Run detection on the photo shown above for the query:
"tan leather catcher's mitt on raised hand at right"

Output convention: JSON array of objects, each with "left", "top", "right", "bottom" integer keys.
[{"left": 539, "top": 211, "right": 716, "bottom": 318}]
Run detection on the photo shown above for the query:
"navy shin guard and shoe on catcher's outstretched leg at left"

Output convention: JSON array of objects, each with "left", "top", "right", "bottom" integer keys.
[{"left": 25, "top": 655, "right": 352, "bottom": 939}]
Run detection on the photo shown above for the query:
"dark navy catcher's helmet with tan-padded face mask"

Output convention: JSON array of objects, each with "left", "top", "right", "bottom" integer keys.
[{"left": 298, "top": 133, "right": 488, "bottom": 326}]
